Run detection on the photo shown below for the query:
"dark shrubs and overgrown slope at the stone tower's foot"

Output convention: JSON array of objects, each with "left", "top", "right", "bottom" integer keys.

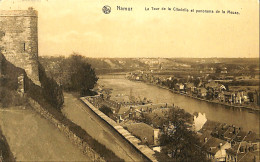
[{"left": 0, "top": 54, "right": 63, "bottom": 110}]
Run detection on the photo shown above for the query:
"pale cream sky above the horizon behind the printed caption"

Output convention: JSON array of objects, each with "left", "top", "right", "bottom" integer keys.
[{"left": 0, "top": 0, "right": 259, "bottom": 58}]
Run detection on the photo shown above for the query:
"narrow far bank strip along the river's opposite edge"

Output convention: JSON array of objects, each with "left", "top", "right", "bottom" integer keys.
[{"left": 128, "top": 79, "right": 260, "bottom": 113}]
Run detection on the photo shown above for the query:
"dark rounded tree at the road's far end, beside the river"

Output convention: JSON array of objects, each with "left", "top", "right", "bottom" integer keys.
[{"left": 68, "top": 54, "right": 98, "bottom": 96}]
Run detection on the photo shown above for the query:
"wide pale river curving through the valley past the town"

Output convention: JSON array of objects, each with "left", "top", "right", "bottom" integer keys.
[{"left": 98, "top": 75, "right": 259, "bottom": 133}]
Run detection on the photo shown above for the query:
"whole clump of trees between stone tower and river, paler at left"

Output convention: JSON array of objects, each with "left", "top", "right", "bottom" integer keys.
[{"left": 40, "top": 53, "right": 98, "bottom": 96}]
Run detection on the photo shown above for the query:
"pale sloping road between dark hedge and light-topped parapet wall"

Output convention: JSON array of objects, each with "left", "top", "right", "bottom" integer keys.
[{"left": 62, "top": 93, "right": 145, "bottom": 161}]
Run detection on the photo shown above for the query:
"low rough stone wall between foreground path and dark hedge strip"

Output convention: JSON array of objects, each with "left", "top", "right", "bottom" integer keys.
[{"left": 29, "top": 99, "right": 105, "bottom": 162}]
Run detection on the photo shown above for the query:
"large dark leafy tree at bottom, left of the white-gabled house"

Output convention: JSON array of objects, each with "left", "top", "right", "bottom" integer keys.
[{"left": 160, "top": 110, "right": 207, "bottom": 161}]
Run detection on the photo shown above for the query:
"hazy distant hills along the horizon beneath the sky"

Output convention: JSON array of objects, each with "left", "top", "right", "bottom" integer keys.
[{"left": 39, "top": 56, "right": 259, "bottom": 74}]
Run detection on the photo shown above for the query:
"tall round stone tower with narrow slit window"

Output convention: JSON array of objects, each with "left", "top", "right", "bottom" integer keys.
[{"left": 0, "top": 8, "right": 40, "bottom": 85}]
